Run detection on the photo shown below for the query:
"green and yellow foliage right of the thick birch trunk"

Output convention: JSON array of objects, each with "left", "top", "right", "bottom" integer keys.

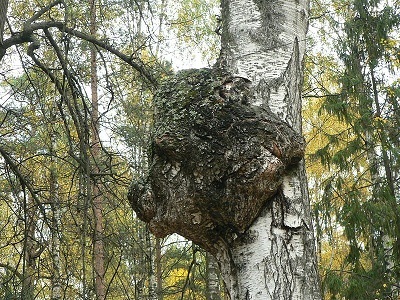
[{"left": 305, "top": 0, "right": 400, "bottom": 299}]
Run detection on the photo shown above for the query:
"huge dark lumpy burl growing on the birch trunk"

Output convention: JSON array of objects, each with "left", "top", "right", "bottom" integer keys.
[{"left": 128, "top": 69, "right": 305, "bottom": 253}]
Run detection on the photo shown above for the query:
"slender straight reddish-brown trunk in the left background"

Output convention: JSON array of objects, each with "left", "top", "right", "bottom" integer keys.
[{"left": 89, "top": 0, "right": 106, "bottom": 300}]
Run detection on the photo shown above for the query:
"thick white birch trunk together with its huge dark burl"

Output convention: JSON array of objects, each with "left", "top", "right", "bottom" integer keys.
[{"left": 128, "top": 0, "right": 321, "bottom": 300}]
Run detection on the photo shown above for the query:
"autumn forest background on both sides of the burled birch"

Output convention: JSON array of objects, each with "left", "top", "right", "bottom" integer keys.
[{"left": 0, "top": 0, "right": 400, "bottom": 300}]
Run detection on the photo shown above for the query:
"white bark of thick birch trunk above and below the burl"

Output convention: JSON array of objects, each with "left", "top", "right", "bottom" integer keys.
[{"left": 216, "top": 0, "right": 321, "bottom": 300}]
